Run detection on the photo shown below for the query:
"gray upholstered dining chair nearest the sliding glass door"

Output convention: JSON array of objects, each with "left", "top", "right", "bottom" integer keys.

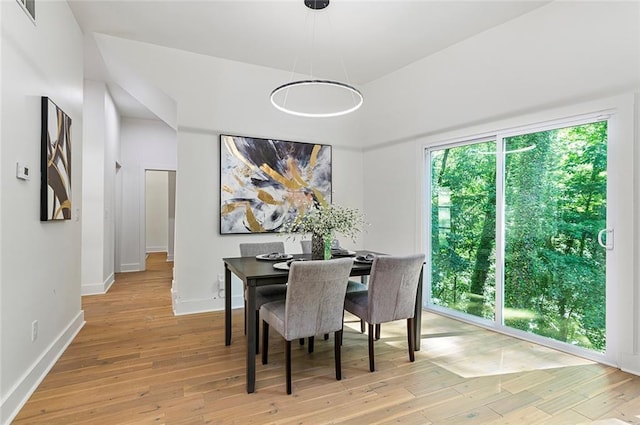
[{"left": 344, "top": 254, "right": 425, "bottom": 372}]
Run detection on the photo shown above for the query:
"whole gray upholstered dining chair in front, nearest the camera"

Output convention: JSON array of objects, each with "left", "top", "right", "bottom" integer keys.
[{"left": 260, "top": 258, "right": 353, "bottom": 394}]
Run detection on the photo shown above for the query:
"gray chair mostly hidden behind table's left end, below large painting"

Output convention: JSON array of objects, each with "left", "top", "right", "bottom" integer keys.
[{"left": 240, "top": 242, "right": 287, "bottom": 353}]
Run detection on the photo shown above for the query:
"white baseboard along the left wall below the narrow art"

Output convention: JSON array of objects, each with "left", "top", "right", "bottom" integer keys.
[{"left": 0, "top": 310, "right": 85, "bottom": 425}]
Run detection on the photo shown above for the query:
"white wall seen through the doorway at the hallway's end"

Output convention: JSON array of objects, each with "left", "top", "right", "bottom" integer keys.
[{"left": 145, "top": 170, "right": 169, "bottom": 253}]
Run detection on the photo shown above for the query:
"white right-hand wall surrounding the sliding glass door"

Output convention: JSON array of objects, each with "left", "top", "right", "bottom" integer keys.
[{"left": 363, "top": 2, "right": 640, "bottom": 374}]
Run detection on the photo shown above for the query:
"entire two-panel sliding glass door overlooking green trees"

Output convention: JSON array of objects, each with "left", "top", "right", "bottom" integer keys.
[{"left": 428, "top": 121, "right": 607, "bottom": 353}]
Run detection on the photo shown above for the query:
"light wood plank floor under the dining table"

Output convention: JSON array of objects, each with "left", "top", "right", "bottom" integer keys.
[{"left": 14, "top": 255, "right": 640, "bottom": 425}]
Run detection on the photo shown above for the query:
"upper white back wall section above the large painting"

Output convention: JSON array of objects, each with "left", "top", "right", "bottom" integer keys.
[{"left": 96, "top": 34, "right": 360, "bottom": 146}]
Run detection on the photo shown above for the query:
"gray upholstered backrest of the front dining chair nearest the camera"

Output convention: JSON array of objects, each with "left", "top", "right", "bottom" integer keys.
[{"left": 283, "top": 258, "right": 353, "bottom": 341}]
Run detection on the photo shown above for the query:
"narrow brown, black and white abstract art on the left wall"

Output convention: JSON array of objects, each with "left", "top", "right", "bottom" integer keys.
[{"left": 40, "top": 96, "right": 71, "bottom": 221}]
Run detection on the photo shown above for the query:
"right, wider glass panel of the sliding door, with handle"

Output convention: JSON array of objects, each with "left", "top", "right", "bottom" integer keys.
[{"left": 504, "top": 121, "right": 607, "bottom": 352}]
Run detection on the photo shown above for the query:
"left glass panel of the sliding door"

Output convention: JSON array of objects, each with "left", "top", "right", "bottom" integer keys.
[{"left": 430, "top": 141, "right": 496, "bottom": 319}]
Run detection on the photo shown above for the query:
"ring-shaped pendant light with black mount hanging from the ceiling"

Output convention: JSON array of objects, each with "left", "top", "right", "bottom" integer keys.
[{"left": 270, "top": 0, "right": 364, "bottom": 118}]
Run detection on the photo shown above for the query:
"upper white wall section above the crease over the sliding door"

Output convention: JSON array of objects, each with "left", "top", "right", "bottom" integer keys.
[{"left": 362, "top": 1, "right": 640, "bottom": 145}]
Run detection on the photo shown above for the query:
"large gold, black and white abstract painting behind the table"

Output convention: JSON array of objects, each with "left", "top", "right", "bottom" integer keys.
[{"left": 220, "top": 135, "right": 331, "bottom": 234}]
